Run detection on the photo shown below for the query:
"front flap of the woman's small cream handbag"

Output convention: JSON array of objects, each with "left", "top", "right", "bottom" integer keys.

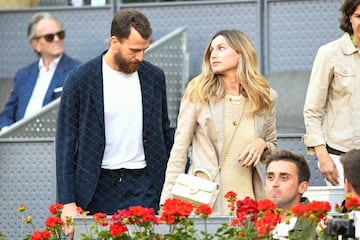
[{"left": 176, "top": 173, "right": 218, "bottom": 192}]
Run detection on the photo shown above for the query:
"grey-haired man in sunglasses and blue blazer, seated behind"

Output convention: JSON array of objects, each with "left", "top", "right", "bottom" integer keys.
[{"left": 0, "top": 12, "right": 80, "bottom": 129}]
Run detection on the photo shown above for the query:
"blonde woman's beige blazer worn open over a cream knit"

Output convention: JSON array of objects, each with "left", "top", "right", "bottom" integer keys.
[{"left": 160, "top": 89, "right": 277, "bottom": 214}]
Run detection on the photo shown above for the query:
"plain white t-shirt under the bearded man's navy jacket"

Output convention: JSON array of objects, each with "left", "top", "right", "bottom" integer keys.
[{"left": 102, "top": 58, "right": 146, "bottom": 169}]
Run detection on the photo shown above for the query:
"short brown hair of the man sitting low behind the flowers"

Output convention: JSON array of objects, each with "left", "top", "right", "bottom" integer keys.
[{"left": 266, "top": 149, "right": 310, "bottom": 183}]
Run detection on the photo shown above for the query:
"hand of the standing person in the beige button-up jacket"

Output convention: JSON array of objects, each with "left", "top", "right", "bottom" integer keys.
[{"left": 315, "top": 145, "right": 339, "bottom": 186}]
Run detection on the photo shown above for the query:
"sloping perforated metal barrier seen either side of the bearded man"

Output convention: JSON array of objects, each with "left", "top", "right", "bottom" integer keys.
[{"left": 0, "top": 28, "right": 189, "bottom": 139}]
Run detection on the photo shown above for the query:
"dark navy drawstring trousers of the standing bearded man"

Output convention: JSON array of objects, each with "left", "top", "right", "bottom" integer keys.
[{"left": 85, "top": 168, "right": 160, "bottom": 215}]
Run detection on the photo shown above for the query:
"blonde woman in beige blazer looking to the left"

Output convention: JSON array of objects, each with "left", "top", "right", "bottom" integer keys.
[{"left": 160, "top": 30, "right": 277, "bottom": 215}]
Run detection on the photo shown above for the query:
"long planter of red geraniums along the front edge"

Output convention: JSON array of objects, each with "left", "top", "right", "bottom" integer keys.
[{"left": 19, "top": 191, "right": 360, "bottom": 240}]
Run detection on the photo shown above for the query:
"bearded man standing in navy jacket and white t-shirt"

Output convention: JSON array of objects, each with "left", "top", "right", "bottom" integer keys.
[{"left": 56, "top": 10, "right": 174, "bottom": 235}]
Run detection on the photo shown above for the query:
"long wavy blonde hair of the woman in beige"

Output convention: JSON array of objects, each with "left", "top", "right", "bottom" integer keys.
[{"left": 185, "top": 30, "right": 271, "bottom": 114}]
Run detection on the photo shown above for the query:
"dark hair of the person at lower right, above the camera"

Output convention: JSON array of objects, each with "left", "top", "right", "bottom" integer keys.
[{"left": 340, "top": 149, "right": 360, "bottom": 195}]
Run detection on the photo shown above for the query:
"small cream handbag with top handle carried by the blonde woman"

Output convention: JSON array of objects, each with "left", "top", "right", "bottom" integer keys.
[{"left": 171, "top": 170, "right": 219, "bottom": 207}]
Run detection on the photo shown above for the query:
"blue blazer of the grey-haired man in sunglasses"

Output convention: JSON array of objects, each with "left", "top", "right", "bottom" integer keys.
[{"left": 0, "top": 54, "right": 80, "bottom": 129}]
